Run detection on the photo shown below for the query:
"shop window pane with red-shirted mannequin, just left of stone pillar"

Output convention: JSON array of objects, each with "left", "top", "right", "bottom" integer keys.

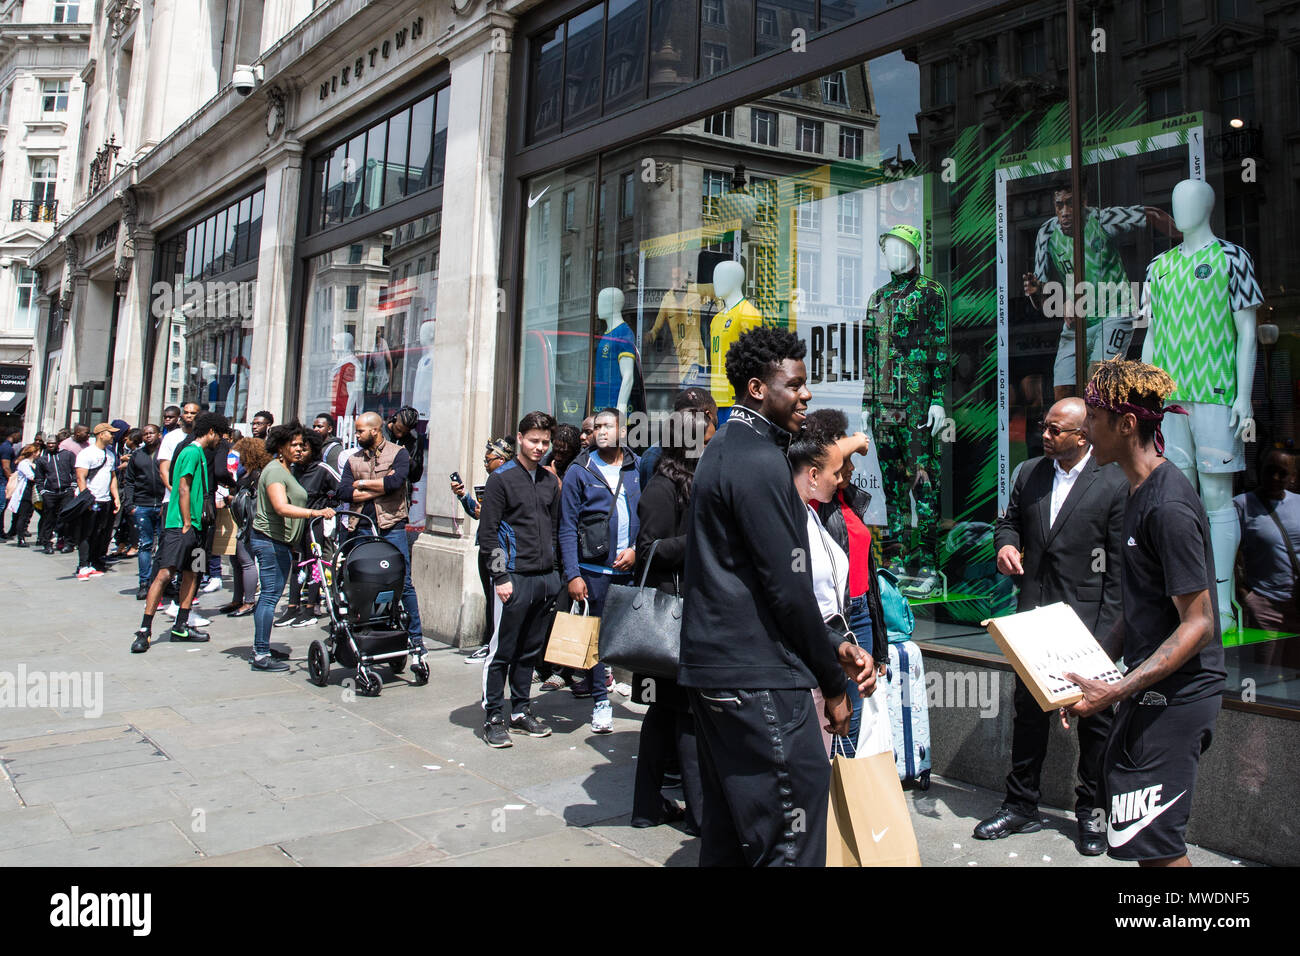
[{"left": 298, "top": 213, "right": 441, "bottom": 529}]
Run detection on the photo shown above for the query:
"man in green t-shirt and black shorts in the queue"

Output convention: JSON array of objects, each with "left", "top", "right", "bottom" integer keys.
[{"left": 131, "top": 411, "right": 230, "bottom": 654}]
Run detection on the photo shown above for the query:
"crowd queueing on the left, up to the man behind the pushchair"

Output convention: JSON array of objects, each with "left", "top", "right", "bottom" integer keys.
[{"left": 8, "top": 402, "right": 424, "bottom": 672}]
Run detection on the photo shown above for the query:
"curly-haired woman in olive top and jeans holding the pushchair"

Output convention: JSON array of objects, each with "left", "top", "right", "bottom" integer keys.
[{"left": 250, "top": 421, "right": 334, "bottom": 671}]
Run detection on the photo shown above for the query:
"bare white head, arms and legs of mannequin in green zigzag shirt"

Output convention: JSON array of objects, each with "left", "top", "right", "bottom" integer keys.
[{"left": 1141, "top": 179, "right": 1257, "bottom": 632}]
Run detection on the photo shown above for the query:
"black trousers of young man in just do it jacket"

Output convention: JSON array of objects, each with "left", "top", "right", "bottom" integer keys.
[{"left": 484, "top": 571, "right": 560, "bottom": 719}]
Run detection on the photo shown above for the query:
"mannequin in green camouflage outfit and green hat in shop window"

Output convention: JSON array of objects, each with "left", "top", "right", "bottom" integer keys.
[{"left": 862, "top": 225, "right": 949, "bottom": 576}]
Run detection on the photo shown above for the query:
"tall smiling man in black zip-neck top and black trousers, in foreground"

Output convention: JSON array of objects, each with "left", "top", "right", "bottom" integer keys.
[{"left": 677, "top": 328, "right": 875, "bottom": 866}]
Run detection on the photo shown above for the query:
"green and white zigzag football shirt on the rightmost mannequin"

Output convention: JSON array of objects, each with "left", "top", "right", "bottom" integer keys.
[{"left": 1143, "top": 239, "right": 1264, "bottom": 406}]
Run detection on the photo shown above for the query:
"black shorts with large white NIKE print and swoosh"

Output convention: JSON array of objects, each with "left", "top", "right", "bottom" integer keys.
[{"left": 1102, "top": 695, "right": 1222, "bottom": 860}]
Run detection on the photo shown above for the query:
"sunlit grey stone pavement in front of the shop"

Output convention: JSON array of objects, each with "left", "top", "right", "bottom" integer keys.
[{"left": 0, "top": 544, "right": 1258, "bottom": 866}]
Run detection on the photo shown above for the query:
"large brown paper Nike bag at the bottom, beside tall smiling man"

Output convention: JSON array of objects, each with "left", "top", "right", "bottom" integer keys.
[{"left": 826, "top": 753, "right": 920, "bottom": 866}]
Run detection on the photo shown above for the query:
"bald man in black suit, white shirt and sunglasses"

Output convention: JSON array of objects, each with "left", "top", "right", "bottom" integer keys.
[{"left": 975, "top": 398, "right": 1128, "bottom": 856}]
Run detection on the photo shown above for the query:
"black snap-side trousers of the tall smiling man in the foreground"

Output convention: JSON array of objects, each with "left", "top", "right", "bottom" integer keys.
[{"left": 690, "top": 688, "right": 831, "bottom": 866}]
